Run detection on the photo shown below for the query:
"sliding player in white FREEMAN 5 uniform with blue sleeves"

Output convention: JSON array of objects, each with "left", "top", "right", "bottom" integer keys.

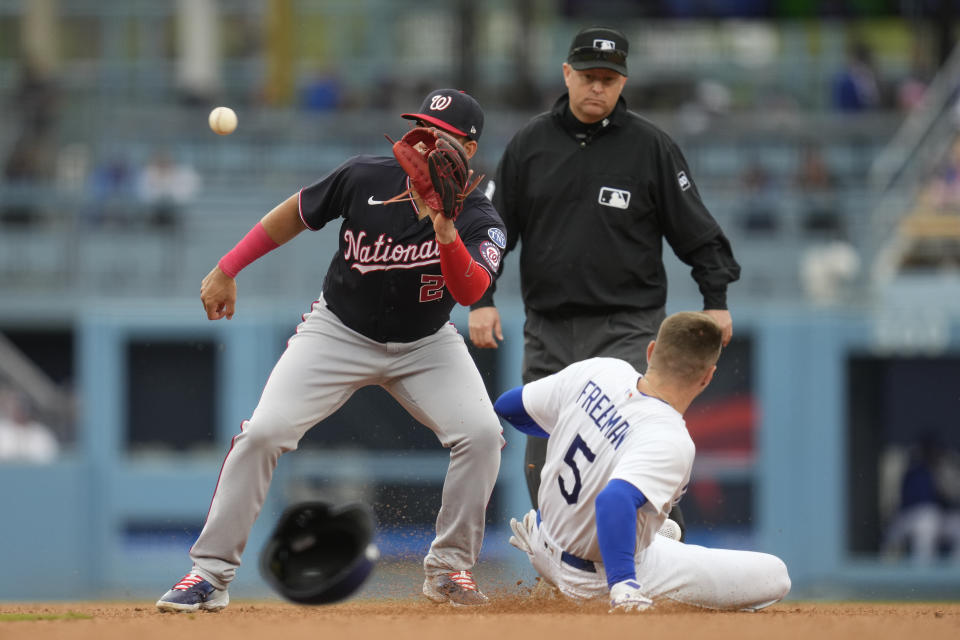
[{"left": 494, "top": 312, "right": 790, "bottom": 611}]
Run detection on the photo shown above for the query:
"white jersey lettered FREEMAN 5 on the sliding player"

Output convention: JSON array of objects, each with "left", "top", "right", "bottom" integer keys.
[{"left": 523, "top": 358, "right": 695, "bottom": 561}]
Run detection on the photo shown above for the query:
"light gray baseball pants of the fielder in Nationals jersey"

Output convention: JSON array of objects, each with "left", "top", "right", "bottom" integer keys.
[{"left": 190, "top": 299, "right": 505, "bottom": 589}]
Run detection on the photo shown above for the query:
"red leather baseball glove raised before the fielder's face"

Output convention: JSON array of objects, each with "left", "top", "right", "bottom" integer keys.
[{"left": 383, "top": 127, "right": 483, "bottom": 220}]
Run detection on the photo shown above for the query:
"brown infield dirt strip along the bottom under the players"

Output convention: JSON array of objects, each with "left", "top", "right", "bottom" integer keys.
[{"left": 0, "top": 595, "right": 960, "bottom": 640}]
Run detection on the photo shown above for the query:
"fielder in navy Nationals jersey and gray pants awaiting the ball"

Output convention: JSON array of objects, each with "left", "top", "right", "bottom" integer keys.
[{"left": 157, "top": 89, "right": 506, "bottom": 611}]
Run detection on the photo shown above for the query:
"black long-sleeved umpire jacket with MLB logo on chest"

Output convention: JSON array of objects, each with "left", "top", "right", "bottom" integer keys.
[{"left": 472, "top": 95, "right": 740, "bottom": 314}]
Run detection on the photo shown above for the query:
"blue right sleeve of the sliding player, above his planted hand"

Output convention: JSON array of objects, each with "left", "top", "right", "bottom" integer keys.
[{"left": 594, "top": 479, "right": 647, "bottom": 587}]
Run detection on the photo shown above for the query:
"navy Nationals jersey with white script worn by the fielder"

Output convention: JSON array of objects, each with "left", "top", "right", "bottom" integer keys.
[{"left": 300, "top": 156, "right": 507, "bottom": 342}]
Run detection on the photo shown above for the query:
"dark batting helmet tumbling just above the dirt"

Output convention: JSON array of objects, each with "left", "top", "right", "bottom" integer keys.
[{"left": 260, "top": 502, "right": 380, "bottom": 604}]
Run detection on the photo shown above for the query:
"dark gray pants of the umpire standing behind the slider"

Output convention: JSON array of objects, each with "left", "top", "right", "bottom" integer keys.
[{"left": 522, "top": 307, "right": 667, "bottom": 508}]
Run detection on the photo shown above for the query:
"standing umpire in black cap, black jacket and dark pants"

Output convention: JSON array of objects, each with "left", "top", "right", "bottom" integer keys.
[{"left": 469, "top": 27, "right": 740, "bottom": 524}]
